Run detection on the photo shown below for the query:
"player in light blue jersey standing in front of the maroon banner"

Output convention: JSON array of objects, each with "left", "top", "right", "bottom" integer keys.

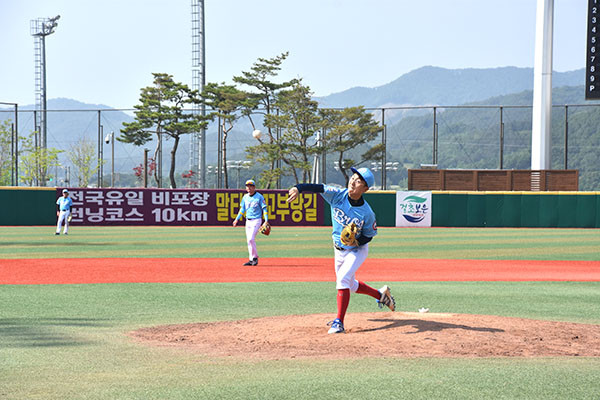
[{"left": 233, "top": 179, "right": 269, "bottom": 266}]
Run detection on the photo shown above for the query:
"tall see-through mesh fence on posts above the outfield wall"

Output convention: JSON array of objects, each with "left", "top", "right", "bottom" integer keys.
[{"left": 0, "top": 104, "right": 600, "bottom": 190}]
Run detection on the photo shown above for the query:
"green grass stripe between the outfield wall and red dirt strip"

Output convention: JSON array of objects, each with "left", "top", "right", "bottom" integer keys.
[{"left": 0, "top": 227, "right": 600, "bottom": 260}]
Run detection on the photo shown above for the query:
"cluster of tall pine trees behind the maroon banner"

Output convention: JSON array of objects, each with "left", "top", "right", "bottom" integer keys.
[{"left": 117, "top": 53, "right": 383, "bottom": 189}]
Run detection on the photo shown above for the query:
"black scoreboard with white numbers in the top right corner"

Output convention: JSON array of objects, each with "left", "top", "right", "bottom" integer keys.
[{"left": 585, "top": 0, "right": 600, "bottom": 100}]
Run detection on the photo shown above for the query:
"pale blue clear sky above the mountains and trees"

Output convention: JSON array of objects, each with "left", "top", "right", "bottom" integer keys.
[{"left": 0, "top": 0, "right": 587, "bottom": 109}]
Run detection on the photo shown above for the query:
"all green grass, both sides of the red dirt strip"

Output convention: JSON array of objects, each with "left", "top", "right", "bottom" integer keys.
[{"left": 0, "top": 226, "right": 600, "bottom": 400}]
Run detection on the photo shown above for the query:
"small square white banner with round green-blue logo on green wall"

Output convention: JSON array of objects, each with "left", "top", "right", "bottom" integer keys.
[{"left": 396, "top": 192, "right": 431, "bottom": 227}]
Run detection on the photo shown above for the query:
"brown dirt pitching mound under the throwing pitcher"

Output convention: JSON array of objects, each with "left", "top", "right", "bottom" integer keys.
[{"left": 129, "top": 312, "right": 600, "bottom": 359}]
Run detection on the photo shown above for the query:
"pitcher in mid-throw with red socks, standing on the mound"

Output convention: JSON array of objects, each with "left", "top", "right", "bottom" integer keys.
[{"left": 288, "top": 168, "right": 396, "bottom": 333}]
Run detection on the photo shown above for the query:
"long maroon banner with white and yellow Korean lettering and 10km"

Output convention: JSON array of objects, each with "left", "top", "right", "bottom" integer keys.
[{"left": 56, "top": 188, "right": 323, "bottom": 226}]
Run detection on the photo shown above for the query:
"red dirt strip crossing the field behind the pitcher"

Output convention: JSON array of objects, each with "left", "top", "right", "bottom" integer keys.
[{"left": 0, "top": 258, "right": 600, "bottom": 285}]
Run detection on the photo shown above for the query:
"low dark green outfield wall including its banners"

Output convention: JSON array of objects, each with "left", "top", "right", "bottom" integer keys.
[{"left": 0, "top": 187, "right": 600, "bottom": 228}]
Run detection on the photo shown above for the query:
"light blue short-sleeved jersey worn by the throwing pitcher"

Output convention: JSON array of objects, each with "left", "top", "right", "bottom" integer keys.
[{"left": 321, "top": 185, "right": 377, "bottom": 249}]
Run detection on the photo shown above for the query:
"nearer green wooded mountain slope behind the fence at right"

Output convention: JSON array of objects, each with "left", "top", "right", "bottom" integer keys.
[{"left": 387, "top": 85, "right": 600, "bottom": 190}]
